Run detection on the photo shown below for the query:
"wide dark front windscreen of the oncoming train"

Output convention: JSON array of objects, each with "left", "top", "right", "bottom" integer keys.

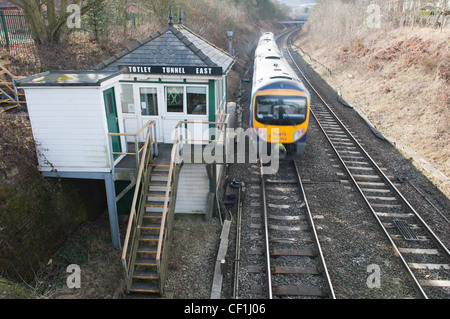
[{"left": 255, "top": 95, "right": 308, "bottom": 125}]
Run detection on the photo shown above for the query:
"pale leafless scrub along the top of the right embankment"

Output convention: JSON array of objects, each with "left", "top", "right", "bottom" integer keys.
[{"left": 304, "top": 0, "right": 450, "bottom": 47}]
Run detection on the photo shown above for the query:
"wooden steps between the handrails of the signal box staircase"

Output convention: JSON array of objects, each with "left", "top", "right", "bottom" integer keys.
[{"left": 129, "top": 164, "right": 171, "bottom": 294}]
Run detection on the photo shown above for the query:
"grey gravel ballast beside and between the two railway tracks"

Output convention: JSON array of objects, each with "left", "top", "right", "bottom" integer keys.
[{"left": 161, "top": 32, "right": 450, "bottom": 299}]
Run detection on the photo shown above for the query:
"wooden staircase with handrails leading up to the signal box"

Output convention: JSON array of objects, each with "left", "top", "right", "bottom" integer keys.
[{"left": 121, "top": 118, "right": 228, "bottom": 296}]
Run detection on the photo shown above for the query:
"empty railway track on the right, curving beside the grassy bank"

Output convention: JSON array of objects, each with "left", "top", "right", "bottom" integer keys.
[{"left": 279, "top": 28, "right": 450, "bottom": 298}]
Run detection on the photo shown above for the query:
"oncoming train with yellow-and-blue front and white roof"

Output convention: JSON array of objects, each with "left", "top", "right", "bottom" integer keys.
[{"left": 250, "top": 32, "right": 310, "bottom": 154}]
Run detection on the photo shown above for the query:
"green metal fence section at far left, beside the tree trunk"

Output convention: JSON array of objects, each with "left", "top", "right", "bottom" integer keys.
[{"left": 0, "top": 10, "right": 34, "bottom": 55}]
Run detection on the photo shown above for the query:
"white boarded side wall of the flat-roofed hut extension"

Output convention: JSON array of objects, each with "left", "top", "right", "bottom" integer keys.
[{"left": 25, "top": 87, "right": 110, "bottom": 172}]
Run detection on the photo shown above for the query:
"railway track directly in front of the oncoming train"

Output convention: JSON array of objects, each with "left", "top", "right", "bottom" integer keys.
[{"left": 243, "top": 160, "right": 335, "bottom": 299}]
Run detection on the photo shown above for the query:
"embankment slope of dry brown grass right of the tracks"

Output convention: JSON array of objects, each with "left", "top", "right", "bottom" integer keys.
[{"left": 295, "top": 27, "right": 450, "bottom": 196}]
